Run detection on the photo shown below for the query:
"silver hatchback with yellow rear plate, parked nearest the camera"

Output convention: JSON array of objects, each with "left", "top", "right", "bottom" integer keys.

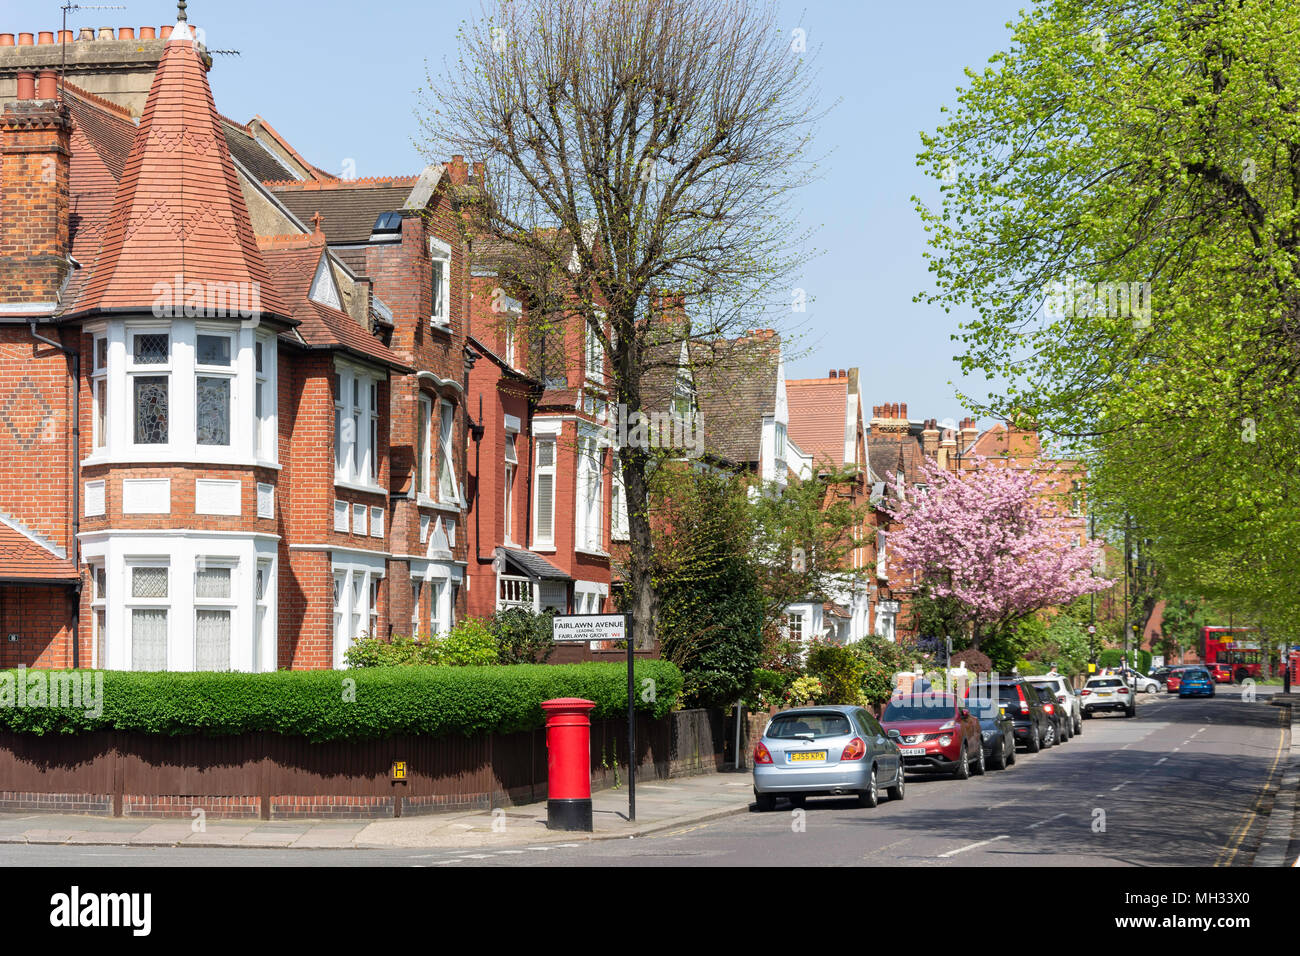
[{"left": 754, "top": 706, "right": 904, "bottom": 810}]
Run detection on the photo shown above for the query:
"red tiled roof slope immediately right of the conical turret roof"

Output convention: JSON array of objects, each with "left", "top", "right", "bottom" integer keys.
[{"left": 257, "top": 233, "right": 408, "bottom": 369}]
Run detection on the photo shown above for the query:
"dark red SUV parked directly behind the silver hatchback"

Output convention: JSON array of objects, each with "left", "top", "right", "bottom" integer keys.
[{"left": 880, "top": 692, "right": 984, "bottom": 780}]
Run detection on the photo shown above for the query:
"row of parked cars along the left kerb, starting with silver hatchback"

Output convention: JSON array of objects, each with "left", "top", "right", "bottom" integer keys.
[{"left": 754, "top": 674, "right": 1136, "bottom": 810}]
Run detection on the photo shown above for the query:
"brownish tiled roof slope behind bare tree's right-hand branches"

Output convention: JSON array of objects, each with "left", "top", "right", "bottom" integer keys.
[{"left": 690, "top": 332, "right": 781, "bottom": 464}]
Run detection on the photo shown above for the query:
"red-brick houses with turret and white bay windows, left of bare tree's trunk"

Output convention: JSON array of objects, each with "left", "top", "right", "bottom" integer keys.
[{"left": 0, "top": 20, "right": 614, "bottom": 671}]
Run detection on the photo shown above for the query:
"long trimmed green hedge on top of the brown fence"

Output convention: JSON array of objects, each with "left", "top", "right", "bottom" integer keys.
[{"left": 0, "top": 661, "right": 683, "bottom": 741}]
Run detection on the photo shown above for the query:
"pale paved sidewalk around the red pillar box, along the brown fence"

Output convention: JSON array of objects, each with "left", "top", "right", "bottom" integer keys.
[{"left": 0, "top": 773, "right": 753, "bottom": 852}]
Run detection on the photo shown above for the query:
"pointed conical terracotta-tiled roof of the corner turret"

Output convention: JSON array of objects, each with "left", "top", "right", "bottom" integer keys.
[{"left": 77, "top": 27, "right": 286, "bottom": 315}]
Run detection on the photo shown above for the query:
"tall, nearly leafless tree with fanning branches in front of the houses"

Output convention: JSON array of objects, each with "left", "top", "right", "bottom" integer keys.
[{"left": 421, "top": 0, "right": 820, "bottom": 645}]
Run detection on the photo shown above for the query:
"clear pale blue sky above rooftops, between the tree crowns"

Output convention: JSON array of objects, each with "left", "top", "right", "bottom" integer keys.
[{"left": 0, "top": 0, "right": 1030, "bottom": 424}]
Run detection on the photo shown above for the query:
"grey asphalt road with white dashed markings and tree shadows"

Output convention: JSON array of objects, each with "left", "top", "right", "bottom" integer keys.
[{"left": 0, "top": 693, "right": 1287, "bottom": 869}]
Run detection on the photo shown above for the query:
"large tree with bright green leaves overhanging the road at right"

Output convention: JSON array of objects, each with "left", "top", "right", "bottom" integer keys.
[{"left": 918, "top": 0, "right": 1300, "bottom": 635}]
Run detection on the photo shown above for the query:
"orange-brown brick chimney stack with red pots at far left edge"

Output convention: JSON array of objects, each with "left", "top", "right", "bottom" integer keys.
[{"left": 0, "top": 85, "right": 72, "bottom": 304}]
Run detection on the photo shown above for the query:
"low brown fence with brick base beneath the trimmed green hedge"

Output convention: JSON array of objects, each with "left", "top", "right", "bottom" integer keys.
[{"left": 0, "top": 710, "right": 724, "bottom": 819}]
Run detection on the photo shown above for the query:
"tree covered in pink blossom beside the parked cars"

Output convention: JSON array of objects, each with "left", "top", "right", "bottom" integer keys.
[{"left": 883, "top": 458, "right": 1112, "bottom": 648}]
